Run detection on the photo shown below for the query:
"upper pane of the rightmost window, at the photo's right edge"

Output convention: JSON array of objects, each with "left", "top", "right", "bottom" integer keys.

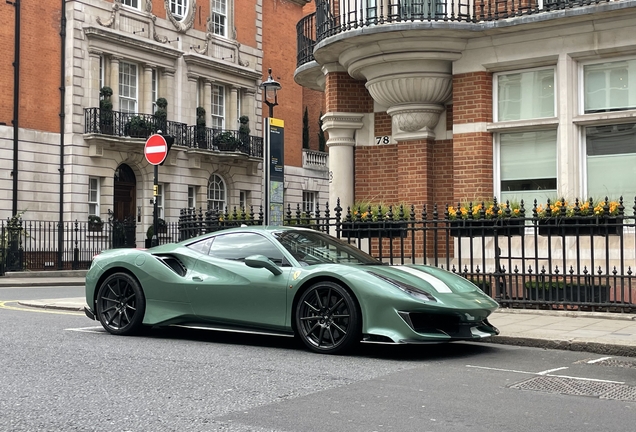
[{"left": 583, "top": 59, "right": 636, "bottom": 114}]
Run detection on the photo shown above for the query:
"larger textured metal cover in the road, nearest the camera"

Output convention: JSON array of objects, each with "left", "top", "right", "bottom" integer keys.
[{"left": 510, "top": 376, "right": 636, "bottom": 401}]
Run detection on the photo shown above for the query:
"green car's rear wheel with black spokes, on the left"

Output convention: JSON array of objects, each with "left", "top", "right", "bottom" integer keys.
[{"left": 97, "top": 273, "right": 146, "bottom": 335}]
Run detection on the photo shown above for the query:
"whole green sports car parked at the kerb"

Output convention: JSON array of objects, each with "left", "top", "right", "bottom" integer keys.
[{"left": 86, "top": 227, "right": 499, "bottom": 354}]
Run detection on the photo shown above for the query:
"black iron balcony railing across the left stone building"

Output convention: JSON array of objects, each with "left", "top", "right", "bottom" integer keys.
[{"left": 84, "top": 108, "right": 263, "bottom": 157}]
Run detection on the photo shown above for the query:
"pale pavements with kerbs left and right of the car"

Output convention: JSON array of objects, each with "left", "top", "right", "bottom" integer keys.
[{"left": 0, "top": 270, "right": 636, "bottom": 357}]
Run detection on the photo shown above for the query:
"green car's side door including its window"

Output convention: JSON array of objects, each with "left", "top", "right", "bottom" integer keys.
[{"left": 188, "top": 233, "right": 291, "bottom": 328}]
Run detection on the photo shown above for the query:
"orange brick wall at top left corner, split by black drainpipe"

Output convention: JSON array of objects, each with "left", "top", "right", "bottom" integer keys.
[{"left": 0, "top": 2, "right": 60, "bottom": 132}]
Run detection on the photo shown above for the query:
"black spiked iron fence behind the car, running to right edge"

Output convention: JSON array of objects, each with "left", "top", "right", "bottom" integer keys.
[{"left": 179, "top": 199, "right": 636, "bottom": 312}]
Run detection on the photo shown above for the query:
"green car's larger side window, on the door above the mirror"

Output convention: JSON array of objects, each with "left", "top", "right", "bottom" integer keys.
[{"left": 209, "top": 233, "right": 287, "bottom": 266}]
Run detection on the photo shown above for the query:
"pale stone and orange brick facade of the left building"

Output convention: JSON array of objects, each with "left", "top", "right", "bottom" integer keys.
[{"left": 0, "top": 0, "right": 327, "bottom": 243}]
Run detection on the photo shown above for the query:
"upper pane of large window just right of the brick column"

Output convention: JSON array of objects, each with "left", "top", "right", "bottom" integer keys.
[{"left": 495, "top": 68, "right": 556, "bottom": 122}]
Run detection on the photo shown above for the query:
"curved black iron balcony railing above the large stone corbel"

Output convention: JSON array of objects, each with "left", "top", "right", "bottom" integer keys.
[{"left": 296, "top": 0, "right": 611, "bottom": 66}]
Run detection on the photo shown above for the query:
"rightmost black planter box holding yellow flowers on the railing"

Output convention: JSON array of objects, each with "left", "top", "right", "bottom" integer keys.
[{"left": 537, "top": 217, "right": 623, "bottom": 236}]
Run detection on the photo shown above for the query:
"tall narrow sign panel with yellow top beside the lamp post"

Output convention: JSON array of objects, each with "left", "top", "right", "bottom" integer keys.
[{"left": 263, "top": 117, "right": 285, "bottom": 225}]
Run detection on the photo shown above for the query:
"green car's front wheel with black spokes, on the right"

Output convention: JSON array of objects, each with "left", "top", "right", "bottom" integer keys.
[{"left": 296, "top": 282, "right": 360, "bottom": 354}]
